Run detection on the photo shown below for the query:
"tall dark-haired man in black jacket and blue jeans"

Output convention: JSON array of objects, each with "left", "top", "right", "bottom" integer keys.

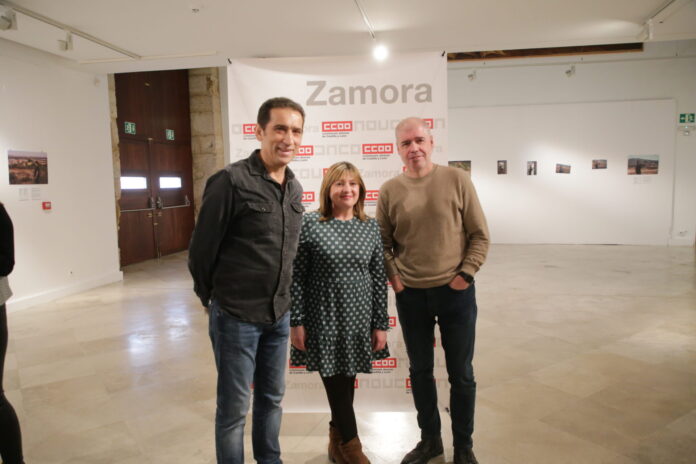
[{"left": 189, "top": 98, "right": 304, "bottom": 464}]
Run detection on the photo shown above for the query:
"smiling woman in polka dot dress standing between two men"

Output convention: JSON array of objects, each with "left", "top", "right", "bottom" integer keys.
[{"left": 290, "top": 162, "right": 389, "bottom": 464}]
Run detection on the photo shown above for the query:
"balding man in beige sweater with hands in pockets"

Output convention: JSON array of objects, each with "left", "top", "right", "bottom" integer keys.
[{"left": 377, "top": 118, "right": 489, "bottom": 464}]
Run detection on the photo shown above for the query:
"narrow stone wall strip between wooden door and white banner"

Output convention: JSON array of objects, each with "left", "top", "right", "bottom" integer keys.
[{"left": 189, "top": 68, "right": 225, "bottom": 217}]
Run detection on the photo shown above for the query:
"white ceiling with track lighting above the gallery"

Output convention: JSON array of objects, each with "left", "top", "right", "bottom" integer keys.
[{"left": 0, "top": 0, "right": 696, "bottom": 72}]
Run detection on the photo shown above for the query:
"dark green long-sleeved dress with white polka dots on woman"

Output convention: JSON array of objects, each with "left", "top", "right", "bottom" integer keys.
[{"left": 290, "top": 212, "right": 389, "bottom": 377}]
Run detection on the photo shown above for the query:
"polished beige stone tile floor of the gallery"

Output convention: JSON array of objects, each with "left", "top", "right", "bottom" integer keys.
[{"left": 5, "top": 245, "right": 696, "bottom": 464}]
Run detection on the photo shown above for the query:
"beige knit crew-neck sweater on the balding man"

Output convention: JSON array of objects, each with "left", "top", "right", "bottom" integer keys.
[{"left": 377, "top": 165, "right": 489, "bottom": 288}]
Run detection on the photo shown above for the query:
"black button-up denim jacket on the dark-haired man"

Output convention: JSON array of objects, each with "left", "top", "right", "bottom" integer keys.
[{"left": 188, "top": 150, "right": 304, "bottom": 323}]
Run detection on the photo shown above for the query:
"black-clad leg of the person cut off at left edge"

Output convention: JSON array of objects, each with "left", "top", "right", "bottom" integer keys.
[{"left": 0, "top": 305, "right": 24, "bottom": 464}]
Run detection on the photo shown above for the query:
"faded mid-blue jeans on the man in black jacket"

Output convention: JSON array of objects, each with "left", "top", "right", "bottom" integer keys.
[{"left": 209, "top": 301, "right": 290, "bottom": 464}]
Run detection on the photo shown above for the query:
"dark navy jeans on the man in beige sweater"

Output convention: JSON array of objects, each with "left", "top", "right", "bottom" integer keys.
[{"left": 396, "top": 284, "right": 477, "bottom": 448}]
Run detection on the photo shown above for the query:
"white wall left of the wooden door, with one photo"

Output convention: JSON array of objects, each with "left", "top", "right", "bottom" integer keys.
[{"left": 0, "top": 40, "right": 122, "bottom": 310}]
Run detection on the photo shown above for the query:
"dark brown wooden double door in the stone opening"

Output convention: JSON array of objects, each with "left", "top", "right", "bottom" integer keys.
[{"left": 115, "top": 70, "right": 194, "bottom": 266}]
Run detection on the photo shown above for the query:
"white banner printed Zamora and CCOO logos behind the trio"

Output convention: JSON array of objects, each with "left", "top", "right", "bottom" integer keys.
[{"left": 228, "top": 52, "right": 449, "bottom": 412}]
